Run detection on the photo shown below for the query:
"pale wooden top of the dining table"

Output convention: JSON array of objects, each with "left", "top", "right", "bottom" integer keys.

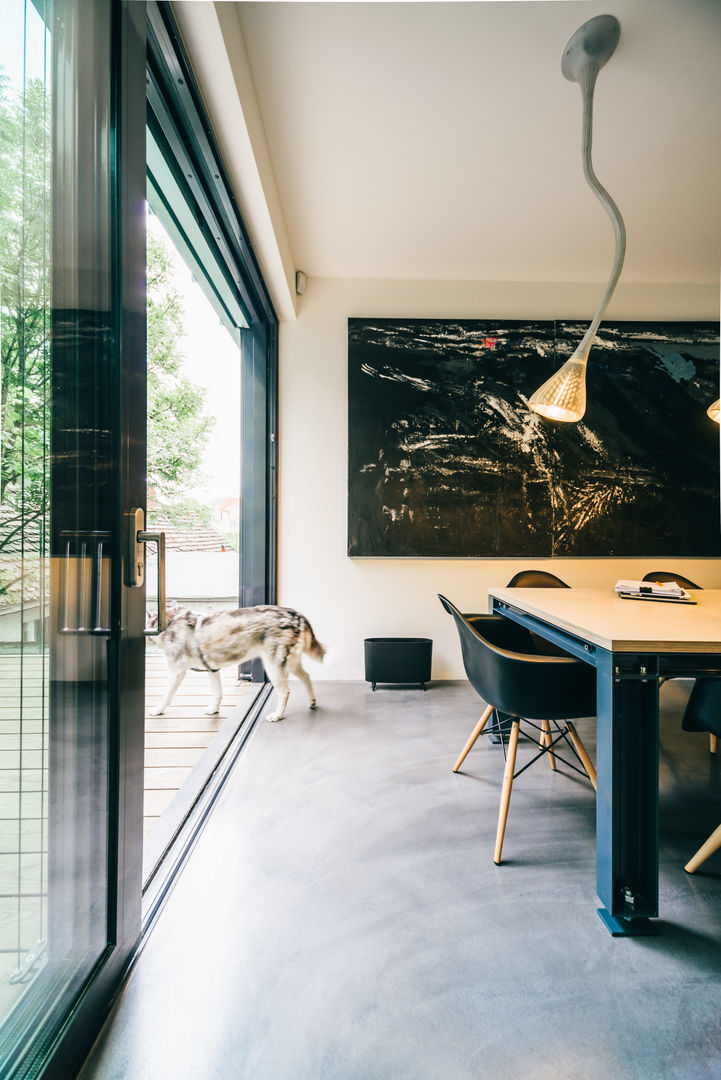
[{"left": 488, "top": 586, "right": 721, "bottom": 652}]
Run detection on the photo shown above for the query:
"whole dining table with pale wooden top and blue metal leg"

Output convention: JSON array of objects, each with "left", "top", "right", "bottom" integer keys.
[{"left": 489, "top": 586, "right": 721, "bottom": 936}]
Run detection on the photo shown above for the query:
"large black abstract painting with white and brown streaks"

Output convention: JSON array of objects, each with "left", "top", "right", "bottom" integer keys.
[{"left": 349, "top": 319, "right": 721, "bottom": 557}]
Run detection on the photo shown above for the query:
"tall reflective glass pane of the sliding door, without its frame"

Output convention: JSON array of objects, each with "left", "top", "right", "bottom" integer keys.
[{"left": 0, "top": 0, "right": 117, "bottom": 1077}]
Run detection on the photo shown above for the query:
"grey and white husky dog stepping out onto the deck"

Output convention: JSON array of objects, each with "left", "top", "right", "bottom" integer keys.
[{"left": 149, "top": 605, "right": 326, "bottom": 720}]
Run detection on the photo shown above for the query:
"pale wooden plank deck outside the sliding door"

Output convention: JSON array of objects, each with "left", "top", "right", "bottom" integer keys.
[{"left": 0, "top": 648, "right": 258, "bottom": 1023}]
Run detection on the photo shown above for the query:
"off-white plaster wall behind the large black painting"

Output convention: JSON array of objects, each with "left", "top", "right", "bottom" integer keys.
[{"left": 278, "top": 279, "right": 721, "bottom": 679}]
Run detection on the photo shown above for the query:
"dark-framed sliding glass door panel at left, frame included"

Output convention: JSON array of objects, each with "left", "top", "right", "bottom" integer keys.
[{"left": 0, "top": 0, "right": 145, "bottom": 1080}]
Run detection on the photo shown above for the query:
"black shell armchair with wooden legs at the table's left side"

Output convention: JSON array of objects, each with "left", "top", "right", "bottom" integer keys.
[{"left": 438, "top": 595, "right": 596, "bottom": 863}]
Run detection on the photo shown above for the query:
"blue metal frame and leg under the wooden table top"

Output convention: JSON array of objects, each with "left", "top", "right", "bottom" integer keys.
[{"left": 490, "top": 596, "right": 721, "bottom": 936}]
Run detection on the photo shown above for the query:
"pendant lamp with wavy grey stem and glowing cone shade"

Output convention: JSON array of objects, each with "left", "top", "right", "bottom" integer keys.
[{"left": 529, "top": 15, "right": 626, "bottom": 422}]
